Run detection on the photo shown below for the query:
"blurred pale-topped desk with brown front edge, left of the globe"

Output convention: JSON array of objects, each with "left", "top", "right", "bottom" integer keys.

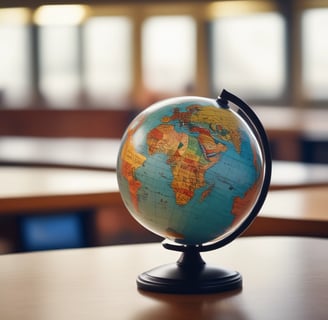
[{"left": 0, "top": 167, "right": 122, "bottom": 214}]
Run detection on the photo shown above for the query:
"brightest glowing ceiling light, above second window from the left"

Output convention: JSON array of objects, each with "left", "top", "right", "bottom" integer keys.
[{"left": 34, "top": 5, "right": 88, "bottom": 25}]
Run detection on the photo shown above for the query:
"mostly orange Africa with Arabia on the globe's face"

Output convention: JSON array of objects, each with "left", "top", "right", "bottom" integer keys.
[{"left": 147, "top": 124, "right": 226, "bottom": 205}]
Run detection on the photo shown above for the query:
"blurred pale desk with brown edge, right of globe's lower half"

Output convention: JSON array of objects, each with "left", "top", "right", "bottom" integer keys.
[{"left": 245, "top": 187, "right": 328, "bottom": 238}]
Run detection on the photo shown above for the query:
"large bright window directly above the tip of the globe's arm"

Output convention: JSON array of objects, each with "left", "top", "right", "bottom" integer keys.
[{"left": 212, "top": 12, "right": 285, "bottom": 100}]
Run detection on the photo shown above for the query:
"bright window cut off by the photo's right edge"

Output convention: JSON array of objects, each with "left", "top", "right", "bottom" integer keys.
[{"left": 302, "top": 9, "right": 328, "bottom": 100}]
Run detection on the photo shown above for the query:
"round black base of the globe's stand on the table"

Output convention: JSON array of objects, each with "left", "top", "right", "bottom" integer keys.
[{"left": 137, "top": 263, "right": 242, "bottom": 294}]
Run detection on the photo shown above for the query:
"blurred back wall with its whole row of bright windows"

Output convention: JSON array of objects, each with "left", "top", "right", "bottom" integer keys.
[{"left": 0, "top": 0, "right": 328, "bottom": 108}]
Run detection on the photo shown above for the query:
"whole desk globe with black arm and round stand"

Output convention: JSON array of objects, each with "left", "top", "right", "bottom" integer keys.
[{"left": 117, "top": 90, "right": 271, "bottom": 293}]
